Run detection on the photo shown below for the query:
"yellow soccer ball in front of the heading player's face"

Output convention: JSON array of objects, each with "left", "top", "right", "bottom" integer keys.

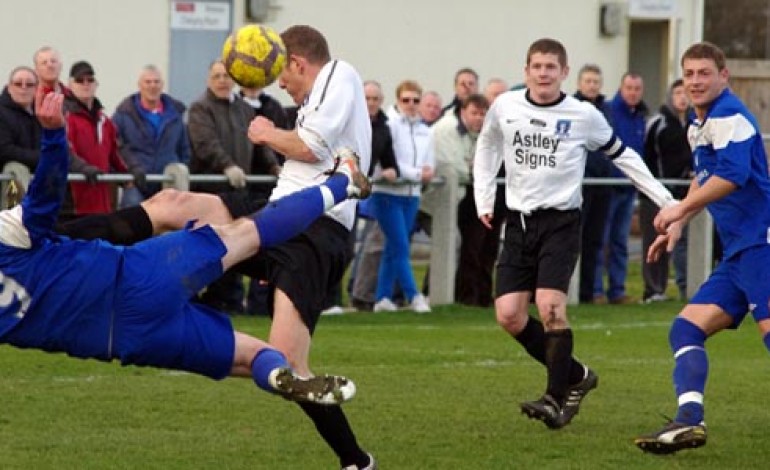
[{"left": 222, "top": 24, "right": 286, "bottom": 88}]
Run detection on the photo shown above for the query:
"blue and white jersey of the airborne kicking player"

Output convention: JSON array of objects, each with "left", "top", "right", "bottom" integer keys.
[{"left": 0, "top": 129, "right": 122, "bottom": 357}]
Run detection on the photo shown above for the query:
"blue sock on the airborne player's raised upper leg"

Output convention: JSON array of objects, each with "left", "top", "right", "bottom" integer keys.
[{"left": 252, "top": 173, "right": 348, "bottom": 248}]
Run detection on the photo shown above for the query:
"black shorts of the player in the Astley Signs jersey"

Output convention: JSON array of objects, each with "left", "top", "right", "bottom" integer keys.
[{"left": 495, "top": 209, "right": 580, "bottom": 297}]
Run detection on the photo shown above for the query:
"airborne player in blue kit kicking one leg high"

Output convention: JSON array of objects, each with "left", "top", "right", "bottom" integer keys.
[{"left": 0, "top": 89, "right": 368, "bottom": 405}]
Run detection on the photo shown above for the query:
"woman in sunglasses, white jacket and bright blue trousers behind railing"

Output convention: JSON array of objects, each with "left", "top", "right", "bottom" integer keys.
[{"left": 371, "top": 80, "right": 434, "bottom": 313}]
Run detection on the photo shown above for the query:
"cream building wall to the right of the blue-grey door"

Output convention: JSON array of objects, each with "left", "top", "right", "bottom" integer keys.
[{"left": 235, "top": 0, "right": 702, "bottom": 108}]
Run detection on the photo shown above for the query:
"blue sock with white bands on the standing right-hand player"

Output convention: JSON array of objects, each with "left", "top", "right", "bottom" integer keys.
[{"left": 669, "top": 317, "right": 708, "bottom": 425}]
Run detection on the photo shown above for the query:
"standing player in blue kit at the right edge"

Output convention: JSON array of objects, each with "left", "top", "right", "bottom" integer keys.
[{"left": 635, "top": 42, "right": 770, "bottom": 454}]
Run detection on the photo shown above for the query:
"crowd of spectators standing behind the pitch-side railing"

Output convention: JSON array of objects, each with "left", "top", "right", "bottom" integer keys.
[{"left": 0, "top": 46, "right": 692, "bottom": 314}]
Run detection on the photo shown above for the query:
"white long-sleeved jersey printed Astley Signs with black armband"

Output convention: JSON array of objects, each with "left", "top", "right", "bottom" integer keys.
[{"left": 473, "top": 89, "right": 673, "bottom": 216}]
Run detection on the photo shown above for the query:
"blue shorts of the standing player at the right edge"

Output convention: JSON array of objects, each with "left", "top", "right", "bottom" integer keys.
[{"left": 690, "top": 245, "right": 770, "bottom": 328}]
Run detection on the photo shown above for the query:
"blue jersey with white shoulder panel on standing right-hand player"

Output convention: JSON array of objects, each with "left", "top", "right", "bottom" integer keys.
[{"left": 688, "top": 89, "right": 770, "bottom": 259}]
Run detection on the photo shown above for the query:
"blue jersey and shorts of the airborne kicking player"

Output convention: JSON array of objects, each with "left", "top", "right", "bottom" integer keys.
[{"left": 0, "top": 126, "right": 235, "bottom": 379}]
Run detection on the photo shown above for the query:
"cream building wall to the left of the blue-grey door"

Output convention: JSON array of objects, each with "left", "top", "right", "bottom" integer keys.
[{"left": 0, "top": 0, "right": 169, "bottom": 112}]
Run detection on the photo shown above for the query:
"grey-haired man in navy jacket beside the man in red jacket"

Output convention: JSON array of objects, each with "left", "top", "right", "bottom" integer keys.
[{"left": 112, "top": 65, "right": 190, "bottom": 207}]
